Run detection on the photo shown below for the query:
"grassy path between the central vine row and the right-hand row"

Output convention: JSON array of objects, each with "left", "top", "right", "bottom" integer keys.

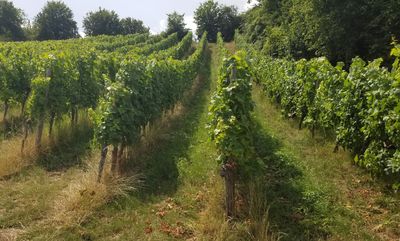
[{"left": 253, "top": 86, "right": 400, "bottom": 241}]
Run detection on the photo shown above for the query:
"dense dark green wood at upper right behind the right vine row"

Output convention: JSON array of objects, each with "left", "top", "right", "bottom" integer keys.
[{"left": 242, "top": 0, "right": 400, "bottom": 64}]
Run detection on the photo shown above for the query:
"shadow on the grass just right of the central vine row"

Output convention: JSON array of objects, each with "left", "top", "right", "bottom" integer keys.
[{"left": 255, "top": 123, "right": 329, "bottom": 241}]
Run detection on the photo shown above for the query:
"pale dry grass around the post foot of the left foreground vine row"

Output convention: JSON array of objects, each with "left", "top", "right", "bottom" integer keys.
[{"left": 51, "top": 159, "right": 139, "bottom": 227}]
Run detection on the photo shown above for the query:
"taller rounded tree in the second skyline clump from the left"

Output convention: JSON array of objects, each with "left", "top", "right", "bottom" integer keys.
[{"left": 83, "top": 8, "right": 122, "bottom": 36}]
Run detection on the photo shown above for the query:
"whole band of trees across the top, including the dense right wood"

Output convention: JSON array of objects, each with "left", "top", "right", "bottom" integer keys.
[{"left": 0, "top": 0, "right": 400, "bottom": 66}]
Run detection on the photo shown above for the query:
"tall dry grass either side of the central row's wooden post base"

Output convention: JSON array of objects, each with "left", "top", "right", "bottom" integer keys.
[{"left": 196, "top": 176, "right": 279, "bottom": 241}]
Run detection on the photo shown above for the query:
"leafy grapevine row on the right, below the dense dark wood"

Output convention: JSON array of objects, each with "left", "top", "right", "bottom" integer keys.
[{"left": 238, "top": 32, "right": 400, "bottom": 186}]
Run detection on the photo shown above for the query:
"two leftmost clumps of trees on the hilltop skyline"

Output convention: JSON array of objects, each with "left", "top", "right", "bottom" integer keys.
[{"left": 0, "top": 0, "right": 149, "bottom": 41}]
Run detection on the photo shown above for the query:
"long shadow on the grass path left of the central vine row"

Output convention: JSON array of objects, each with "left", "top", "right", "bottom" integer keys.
[{"left": 122, "top": 48, "right": 211, "bottom": 199}]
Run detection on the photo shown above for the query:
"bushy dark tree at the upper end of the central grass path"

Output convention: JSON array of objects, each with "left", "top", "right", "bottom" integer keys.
[{"left": 194, "top": 0, "right": 241, "bottom": 42}]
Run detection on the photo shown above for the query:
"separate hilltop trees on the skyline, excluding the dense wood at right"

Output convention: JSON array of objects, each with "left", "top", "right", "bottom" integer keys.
[{"left": 0, "top": 0, "right": 241, "bottom": 42}]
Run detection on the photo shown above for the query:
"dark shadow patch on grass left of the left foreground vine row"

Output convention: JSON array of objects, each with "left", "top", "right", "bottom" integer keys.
[{"left": 36, "top": 120, "right": 93, "bottom": 172}]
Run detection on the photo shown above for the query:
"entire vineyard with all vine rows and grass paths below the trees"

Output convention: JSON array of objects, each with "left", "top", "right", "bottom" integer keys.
[{"left": 0, "top": 25, "right": 400, "bottom": 241}]
